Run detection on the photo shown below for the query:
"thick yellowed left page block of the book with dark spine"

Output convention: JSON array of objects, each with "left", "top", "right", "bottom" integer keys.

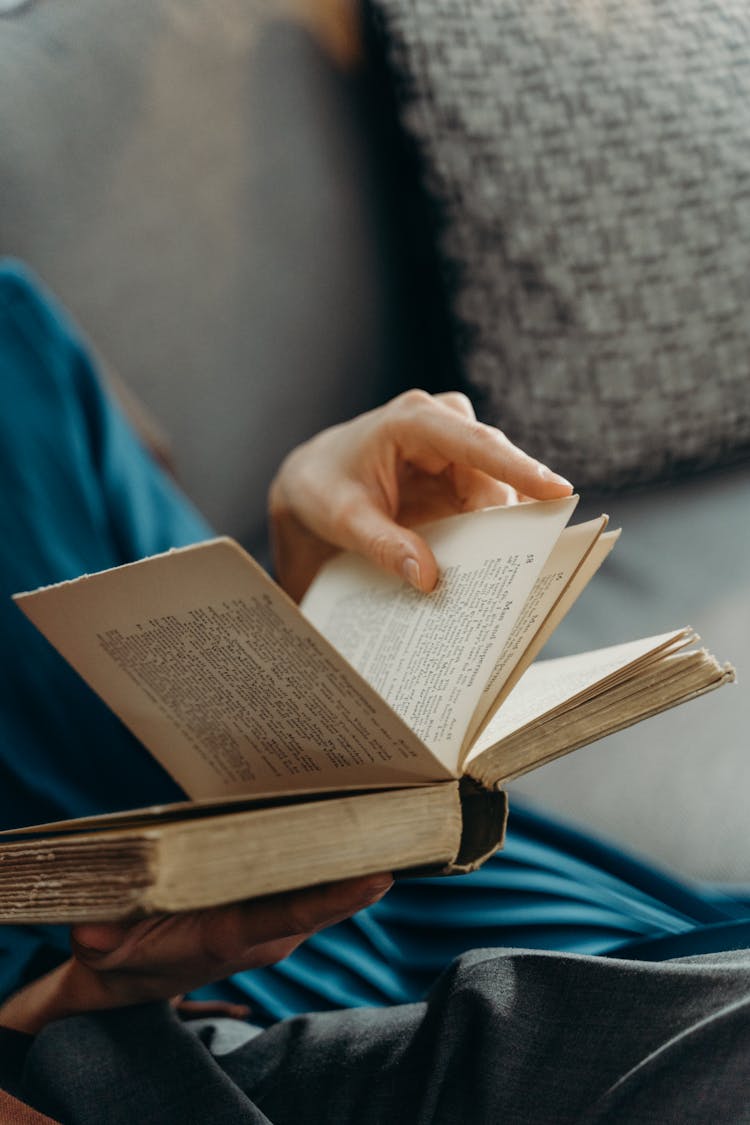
[{"left": 0, "top": 781, "right": 507, "bottom": 923}]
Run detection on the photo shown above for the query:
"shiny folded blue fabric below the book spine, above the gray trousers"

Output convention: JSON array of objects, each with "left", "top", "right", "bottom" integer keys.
[{"left": 227, "top": 800, "right": 750, "bottom": 1019}]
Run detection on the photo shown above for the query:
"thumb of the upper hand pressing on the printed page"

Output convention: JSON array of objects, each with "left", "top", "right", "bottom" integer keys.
[{"left": 344, "top": 502, "right": 439, "bottom": 594}]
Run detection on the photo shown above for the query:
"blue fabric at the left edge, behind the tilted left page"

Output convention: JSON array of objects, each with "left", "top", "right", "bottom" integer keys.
[{"left": 0, "top": 262, "right": 210, "bottom": 995}]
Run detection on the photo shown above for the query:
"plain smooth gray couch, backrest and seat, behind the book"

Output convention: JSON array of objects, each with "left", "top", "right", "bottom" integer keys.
[{"left": 0, "top": 0, "right": 750, "bottom": 883}]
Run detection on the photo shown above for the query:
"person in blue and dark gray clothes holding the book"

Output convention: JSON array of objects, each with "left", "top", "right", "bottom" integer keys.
[{"left": 0, "top": 263, "right": 750, "bottom": 1125}]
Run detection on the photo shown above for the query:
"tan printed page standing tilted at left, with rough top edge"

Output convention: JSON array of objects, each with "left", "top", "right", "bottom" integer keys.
[{"left": 16, "top": 539, "right": 451, "bottom": 798}]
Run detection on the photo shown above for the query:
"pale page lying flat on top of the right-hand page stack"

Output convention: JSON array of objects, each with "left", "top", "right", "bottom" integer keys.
[{"left": 467, "top": 629, "right": 695, "bottom": 764}]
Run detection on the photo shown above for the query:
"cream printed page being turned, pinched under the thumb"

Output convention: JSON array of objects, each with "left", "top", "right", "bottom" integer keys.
[{"left": 301, "top": 497, "right": 577, "bottom": 768}]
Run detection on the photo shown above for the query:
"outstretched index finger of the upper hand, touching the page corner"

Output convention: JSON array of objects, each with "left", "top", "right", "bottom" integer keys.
[{"left": 388, "top": 392, "right": 572, "bottom": 500}]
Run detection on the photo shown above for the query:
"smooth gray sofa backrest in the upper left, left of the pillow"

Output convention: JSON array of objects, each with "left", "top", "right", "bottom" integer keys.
[{"left": 0, "top": 0, "right": 404, "bottom": 547}]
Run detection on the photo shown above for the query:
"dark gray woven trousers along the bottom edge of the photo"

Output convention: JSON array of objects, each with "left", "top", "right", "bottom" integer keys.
[{"left": 10, "top": 950, "right": 750, "bottom": 1125}]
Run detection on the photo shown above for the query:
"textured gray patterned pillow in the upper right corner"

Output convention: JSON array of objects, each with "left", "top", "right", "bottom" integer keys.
[{"left": 372, "top": 0, "right": 750, "bottom": 486}]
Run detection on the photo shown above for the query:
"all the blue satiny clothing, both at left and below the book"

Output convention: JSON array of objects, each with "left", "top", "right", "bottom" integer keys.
[{"left": 0, "top": 262, "right": 750, "bottom": 1019}]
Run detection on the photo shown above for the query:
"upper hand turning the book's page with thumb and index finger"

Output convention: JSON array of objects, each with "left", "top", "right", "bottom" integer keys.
[{"left": 269, "top": 390, "right": 572, "bottom": 601}]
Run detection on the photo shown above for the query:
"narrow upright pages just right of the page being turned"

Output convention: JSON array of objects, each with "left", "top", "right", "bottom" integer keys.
[{"left": 462, "top": 515, "right": 616, "bottom": 761}]
